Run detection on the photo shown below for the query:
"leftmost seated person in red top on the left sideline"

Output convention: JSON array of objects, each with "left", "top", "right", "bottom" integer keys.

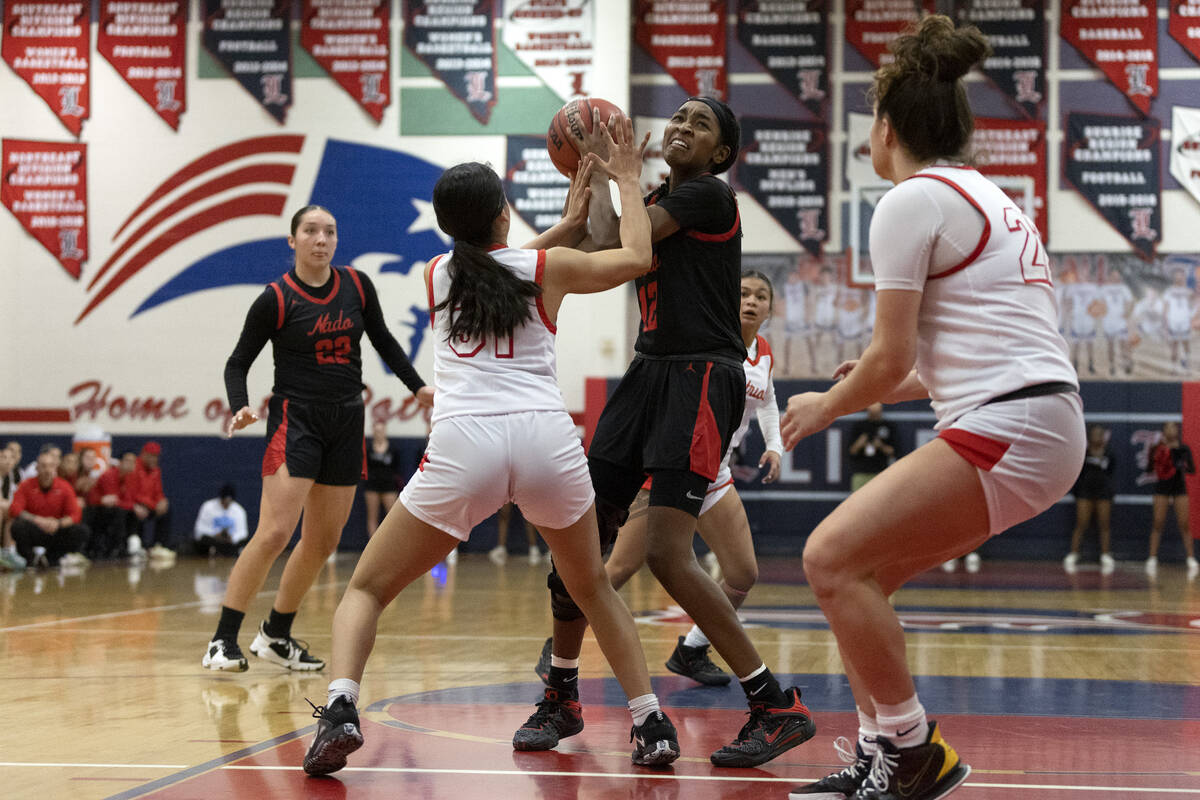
[{"left": 8, "top": 450, "right": 90, "bottom": 566}]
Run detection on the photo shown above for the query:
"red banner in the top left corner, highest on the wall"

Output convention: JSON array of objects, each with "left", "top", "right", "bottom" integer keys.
[{"left": 0, "top": 0, "right": 91, "bottom": 137}]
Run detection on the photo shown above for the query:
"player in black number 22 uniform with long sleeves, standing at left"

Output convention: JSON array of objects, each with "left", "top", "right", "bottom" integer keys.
[{"left": 202, "top": 205, "right": 433, "bottom": 672}]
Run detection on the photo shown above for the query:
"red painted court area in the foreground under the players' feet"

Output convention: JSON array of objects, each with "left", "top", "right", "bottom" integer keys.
[{"left": 129, "top": 696, "right": 1200, "bottom": 800}]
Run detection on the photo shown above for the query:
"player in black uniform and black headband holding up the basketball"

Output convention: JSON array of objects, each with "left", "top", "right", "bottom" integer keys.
[{"left": 514, "top": 97, "right": 816, "bottom": 766}]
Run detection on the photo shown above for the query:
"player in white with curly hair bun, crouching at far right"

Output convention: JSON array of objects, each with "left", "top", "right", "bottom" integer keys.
[{"left": 782, "top": 14, "right": 1086, "bottom": 800}]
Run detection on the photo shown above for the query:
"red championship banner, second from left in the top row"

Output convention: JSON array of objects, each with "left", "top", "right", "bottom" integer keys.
[{"left": 96, "top": 0, "right": 187, "bottom": 131}]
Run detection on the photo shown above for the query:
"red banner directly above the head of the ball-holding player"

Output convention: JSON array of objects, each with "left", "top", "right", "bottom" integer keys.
[{"left": 634, "top": 0, "right": 726, "bottom": 100}]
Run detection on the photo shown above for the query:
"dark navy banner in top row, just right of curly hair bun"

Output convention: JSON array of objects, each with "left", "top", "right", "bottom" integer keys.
[{"left": 955, "top": 0, "right": 1046, "bottom": 120}]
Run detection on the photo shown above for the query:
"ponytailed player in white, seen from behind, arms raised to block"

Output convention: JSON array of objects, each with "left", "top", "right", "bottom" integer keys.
[{"left": 304, "top": 119, "right": 679, "bottom": 775}]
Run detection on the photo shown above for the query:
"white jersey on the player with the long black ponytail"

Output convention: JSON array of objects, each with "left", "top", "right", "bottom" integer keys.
[{"left": 427, "top": 247, "right": 566, "bottom": 422}]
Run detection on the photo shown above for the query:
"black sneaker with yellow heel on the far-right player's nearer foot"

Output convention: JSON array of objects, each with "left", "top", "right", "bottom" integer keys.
[{"left": 854, "top": 721, "right": 971, "bottom": 800}]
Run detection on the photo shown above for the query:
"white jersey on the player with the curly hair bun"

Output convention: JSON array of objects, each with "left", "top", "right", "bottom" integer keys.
[{"left": 871, "top": 167, "right": 1079, "bottom": 428}]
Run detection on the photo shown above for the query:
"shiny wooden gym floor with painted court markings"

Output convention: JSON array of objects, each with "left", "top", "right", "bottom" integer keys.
[{"left": 0, "top": 554, "right": 1200, "bottom": 800}]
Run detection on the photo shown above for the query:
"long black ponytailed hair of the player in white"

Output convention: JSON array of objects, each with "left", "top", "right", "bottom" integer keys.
[{"left": 432, "top": 162, "right": 541, "bottom": 341}]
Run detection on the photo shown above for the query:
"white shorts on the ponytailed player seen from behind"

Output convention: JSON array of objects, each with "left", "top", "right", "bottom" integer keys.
[{"left": 400, "top": 411, "right": 595, "bottom": 541}]
